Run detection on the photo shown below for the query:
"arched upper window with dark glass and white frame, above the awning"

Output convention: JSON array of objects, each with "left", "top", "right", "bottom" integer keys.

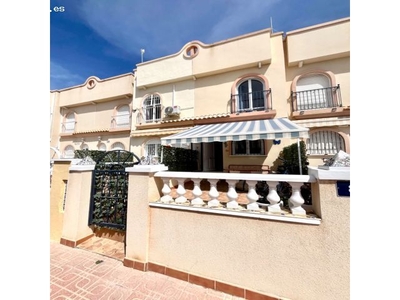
[{"left": 237, "top": 79, "right": 265, "bottom": 112}]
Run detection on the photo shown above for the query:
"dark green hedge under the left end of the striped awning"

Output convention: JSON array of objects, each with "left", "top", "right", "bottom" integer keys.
[{"left": 158, "top": 146, "right": 199, "bottom": 172}]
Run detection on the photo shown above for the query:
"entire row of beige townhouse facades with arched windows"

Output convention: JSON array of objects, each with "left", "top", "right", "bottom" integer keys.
[{"left": 50, "top": 18, "right": 350, "bottom": 172}]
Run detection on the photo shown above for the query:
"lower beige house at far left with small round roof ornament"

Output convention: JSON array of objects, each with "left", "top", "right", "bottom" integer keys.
[{"left": 50, "top": 73, "right": 134, "bottom": 159}]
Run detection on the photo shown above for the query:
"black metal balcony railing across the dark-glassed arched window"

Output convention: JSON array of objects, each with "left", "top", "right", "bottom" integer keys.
[{"left": 231, "top": 89, "right": 272, "bottom": 113}]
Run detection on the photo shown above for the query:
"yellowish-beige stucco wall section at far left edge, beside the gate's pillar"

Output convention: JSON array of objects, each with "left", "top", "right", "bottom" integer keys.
[{"left": 50, "top": 160, "right": 71, "bottom": 241}]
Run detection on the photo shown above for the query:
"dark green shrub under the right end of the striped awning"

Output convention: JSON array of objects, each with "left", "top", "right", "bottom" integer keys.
[{"left": 281, "top": 141, "right": 308, "bottom": 175}]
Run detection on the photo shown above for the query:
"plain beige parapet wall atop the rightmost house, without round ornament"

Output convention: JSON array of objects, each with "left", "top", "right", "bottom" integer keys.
[{"left": 287, "top": 18, "right": 350, "bottom": 66}]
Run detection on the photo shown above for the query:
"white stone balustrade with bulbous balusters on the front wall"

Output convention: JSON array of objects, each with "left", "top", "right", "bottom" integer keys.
[{"left": 151, "top": 171, "right": 319, "bottom": 224}]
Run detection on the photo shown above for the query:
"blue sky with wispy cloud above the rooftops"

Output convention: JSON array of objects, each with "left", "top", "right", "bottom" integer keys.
[{"left": 50, "top": 0, "right": 350, "bottom": 90}]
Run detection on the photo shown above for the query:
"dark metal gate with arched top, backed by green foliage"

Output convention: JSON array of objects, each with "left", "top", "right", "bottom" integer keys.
[{"left": 89, "top": 150, "right": 140, "bottom": 230}]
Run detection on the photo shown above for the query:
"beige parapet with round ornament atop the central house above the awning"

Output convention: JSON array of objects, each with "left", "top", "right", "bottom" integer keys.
[{"left": 136, "top": 29, "right": 272, "bottom": 89}]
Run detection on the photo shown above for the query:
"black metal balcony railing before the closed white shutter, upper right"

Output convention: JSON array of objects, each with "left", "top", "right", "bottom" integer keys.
[{"left": 291, "top": 84, "right": 342, "bottom": 111}]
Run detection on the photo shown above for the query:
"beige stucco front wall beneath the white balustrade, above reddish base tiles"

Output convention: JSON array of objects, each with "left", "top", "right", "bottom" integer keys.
[{"left": 145, "top": 181, "right": 350, "bottom": 300}]
